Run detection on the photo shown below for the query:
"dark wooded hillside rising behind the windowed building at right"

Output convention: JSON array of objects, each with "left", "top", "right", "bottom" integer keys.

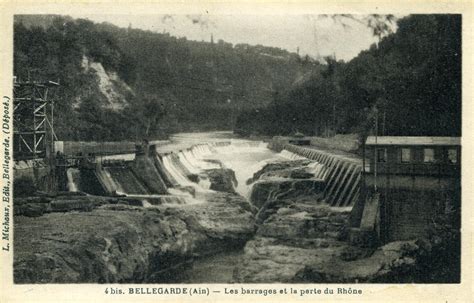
[{"left": 237, "top": 15, "right": 462, "bottom": 136}]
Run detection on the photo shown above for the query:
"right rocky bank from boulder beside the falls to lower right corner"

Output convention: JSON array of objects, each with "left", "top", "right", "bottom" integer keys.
[{"left": 234, "top": 161, "right": 462, "bottom": 283}]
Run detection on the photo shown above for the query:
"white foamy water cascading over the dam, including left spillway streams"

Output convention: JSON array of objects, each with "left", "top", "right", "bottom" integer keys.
[{"left": 67, "top": 132, "right": 324, "bottom": 207}]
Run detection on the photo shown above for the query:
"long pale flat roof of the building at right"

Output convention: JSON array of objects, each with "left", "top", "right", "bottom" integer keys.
[{"left": 365, "top": 136, "right": 461, "bottom": 146}]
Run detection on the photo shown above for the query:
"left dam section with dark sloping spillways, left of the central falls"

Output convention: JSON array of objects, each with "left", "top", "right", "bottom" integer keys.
[{"left": 67, "top": 144, "right": 231, "bottom": 201}]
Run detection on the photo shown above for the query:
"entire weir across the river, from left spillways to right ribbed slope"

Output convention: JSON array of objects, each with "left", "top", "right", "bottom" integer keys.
[{"left": 57, "top": 139, "right": 362, "bottom": 211}]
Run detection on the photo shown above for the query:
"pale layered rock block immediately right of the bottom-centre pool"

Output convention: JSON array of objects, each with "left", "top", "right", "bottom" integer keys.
[{"left": 235, "top": 197, "right": 349, "bottom": 283}]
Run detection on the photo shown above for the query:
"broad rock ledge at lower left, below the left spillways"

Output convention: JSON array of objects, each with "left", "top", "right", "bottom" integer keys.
[{"left": 14, "top": 193, "right": 254, "bottom": 283}]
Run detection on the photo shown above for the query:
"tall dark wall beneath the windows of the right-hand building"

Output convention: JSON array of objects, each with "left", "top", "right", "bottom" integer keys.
[{"left": 365, "top": 175, "right": 460, "bottom": 243}]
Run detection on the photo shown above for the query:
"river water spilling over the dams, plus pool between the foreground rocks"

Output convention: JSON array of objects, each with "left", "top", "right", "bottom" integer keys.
[{"left": 67, "top": 132, "right": 319, "bottom": 283}]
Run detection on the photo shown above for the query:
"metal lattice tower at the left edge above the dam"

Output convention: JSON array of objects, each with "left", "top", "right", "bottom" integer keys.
[{"left": 13, "top": 81, "right": 59, "bottom": 160}]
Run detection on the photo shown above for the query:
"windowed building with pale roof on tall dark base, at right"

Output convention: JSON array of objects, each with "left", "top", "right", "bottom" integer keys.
[{"left": 359, "top": 136, "right": 461, "bottom": 242}]
